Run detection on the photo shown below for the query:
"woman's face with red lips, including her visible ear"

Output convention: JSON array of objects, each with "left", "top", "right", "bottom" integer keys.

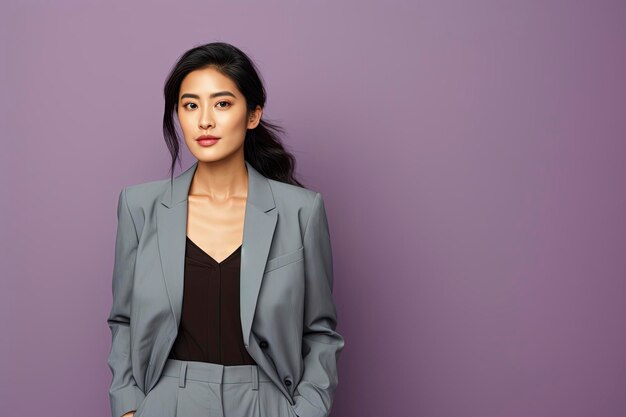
[{"left": 178, "top": 67, "right": 263, "bottom": 162}]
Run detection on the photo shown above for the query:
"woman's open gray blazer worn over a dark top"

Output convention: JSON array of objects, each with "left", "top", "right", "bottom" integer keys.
[{"left": 107, "top": 161, "right": 344, "bottom": 417}]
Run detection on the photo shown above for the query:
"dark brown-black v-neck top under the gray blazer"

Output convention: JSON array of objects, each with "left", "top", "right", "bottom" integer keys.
[{"left": 169, "top": 237, "right": 256, "bottom": 366}]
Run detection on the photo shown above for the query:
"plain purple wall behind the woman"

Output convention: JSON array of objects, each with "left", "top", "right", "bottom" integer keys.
[{"left": 0, "top": 0, "right": 626, "bottom": 417}]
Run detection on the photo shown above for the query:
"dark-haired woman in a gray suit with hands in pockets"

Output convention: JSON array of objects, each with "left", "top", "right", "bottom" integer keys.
[{"left": 107, "top": 42, "right": 344, "bottom": 417}]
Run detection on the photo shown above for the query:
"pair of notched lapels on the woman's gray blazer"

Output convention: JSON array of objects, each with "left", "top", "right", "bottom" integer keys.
[{"left": 156, "top": 161, "right": 277, "bottom": 347}]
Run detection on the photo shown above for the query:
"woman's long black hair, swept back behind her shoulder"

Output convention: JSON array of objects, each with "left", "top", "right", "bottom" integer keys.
[{"left": 163, "top": 42, "right": 303, "bottom": 187}]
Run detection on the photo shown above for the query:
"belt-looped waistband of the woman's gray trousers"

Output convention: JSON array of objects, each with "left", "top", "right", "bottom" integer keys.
[{"left": 163, "top": 358, "right": 271, "bottom": 390}]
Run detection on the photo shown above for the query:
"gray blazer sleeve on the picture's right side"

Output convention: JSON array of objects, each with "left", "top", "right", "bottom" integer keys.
[{"left": 293, "top": 193, "right": 344, "bottom": 417}]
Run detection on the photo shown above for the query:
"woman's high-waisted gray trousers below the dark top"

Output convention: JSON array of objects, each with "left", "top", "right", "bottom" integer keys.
[{"left": 134, "top": 359, "right": 297, "bottom": 417}]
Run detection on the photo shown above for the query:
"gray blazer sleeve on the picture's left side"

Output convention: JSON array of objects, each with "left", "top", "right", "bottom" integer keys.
[{"left": 107, "top": 187, "right": 145, "bottom": 417}]
